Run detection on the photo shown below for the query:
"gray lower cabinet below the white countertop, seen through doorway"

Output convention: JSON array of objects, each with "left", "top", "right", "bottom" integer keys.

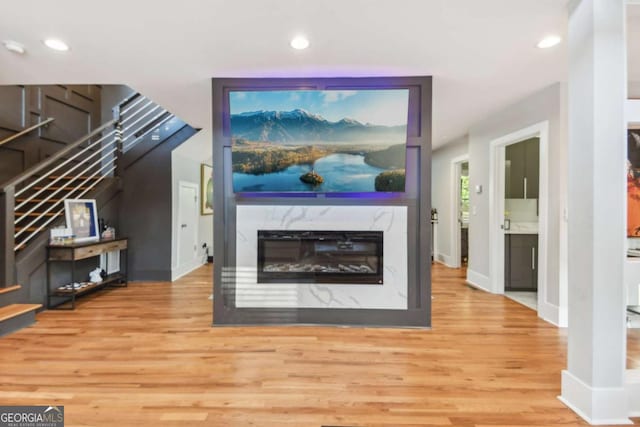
[{"left": 505, "top": 234, "right": 538, "bottom": 291}]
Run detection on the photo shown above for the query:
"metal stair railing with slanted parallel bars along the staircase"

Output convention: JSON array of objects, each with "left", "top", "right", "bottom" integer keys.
[{"left": 0, "top": 94, "right": 174, "bottom": 287}]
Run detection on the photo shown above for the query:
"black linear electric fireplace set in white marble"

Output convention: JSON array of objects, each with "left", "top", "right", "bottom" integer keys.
[{"left": 258, "top": 230, "right": 383, "bottom": 285}]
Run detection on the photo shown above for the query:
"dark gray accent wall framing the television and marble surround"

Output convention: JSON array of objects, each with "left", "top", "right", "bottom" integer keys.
[{"left": 212, "top": 77, "right": 432, "bottom": 327}]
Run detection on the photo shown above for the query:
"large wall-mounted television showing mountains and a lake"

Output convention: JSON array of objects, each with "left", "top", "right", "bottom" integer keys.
[{"left": 229, "top": 88, "right": 409, "bottom": 193}]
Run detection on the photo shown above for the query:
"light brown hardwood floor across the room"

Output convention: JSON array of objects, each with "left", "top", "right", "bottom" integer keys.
[{"left": 0, "top": 265, "right": 640, "bottom": 427}]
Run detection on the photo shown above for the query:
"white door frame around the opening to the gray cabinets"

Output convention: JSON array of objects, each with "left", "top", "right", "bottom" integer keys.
[{"left": 489, "top": 121, "right": 549, "bottom": 312}]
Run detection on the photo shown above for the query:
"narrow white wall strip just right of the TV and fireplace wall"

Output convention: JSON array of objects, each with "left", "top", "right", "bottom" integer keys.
[{"left": 431, "top": 135, "right": 471, "bottom": 265}]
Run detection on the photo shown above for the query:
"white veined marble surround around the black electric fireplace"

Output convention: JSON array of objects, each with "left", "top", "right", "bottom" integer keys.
[{"left": 235, "top": 205, "right": 408, "bottom": 310}]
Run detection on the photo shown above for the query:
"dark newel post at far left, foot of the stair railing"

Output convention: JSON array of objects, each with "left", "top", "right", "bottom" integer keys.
[{"left": 0, "top": 186, "right": 15, "bottom": 288}]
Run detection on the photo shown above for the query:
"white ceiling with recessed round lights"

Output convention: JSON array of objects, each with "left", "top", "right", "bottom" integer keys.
[{"left": 0, "top": 0, "right": 640, "bottom": 152}]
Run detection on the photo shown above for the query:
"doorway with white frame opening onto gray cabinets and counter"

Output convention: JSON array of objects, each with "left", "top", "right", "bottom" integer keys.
[{"left": 489, "top": 122, "right": 548, "bottom": 312}]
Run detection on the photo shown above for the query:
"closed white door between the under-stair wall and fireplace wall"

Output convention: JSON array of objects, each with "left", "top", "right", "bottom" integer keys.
[{"left": 176, "top": 181, "right": 199, "bottom": 272}]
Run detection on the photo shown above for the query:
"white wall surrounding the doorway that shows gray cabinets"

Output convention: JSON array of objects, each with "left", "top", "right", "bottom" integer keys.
[{"left": 467, "top": 83, "right": 567, "bottom": 324}]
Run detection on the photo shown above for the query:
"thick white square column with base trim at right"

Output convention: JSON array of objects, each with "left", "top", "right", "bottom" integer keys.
[{"left": 560, "top": 0, "right": 630, "bottom": 424}]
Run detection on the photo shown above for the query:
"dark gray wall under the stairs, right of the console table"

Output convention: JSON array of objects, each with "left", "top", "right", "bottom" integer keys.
[{"left": 116, "top": 125, "right": 197, "bottom": 281}]
